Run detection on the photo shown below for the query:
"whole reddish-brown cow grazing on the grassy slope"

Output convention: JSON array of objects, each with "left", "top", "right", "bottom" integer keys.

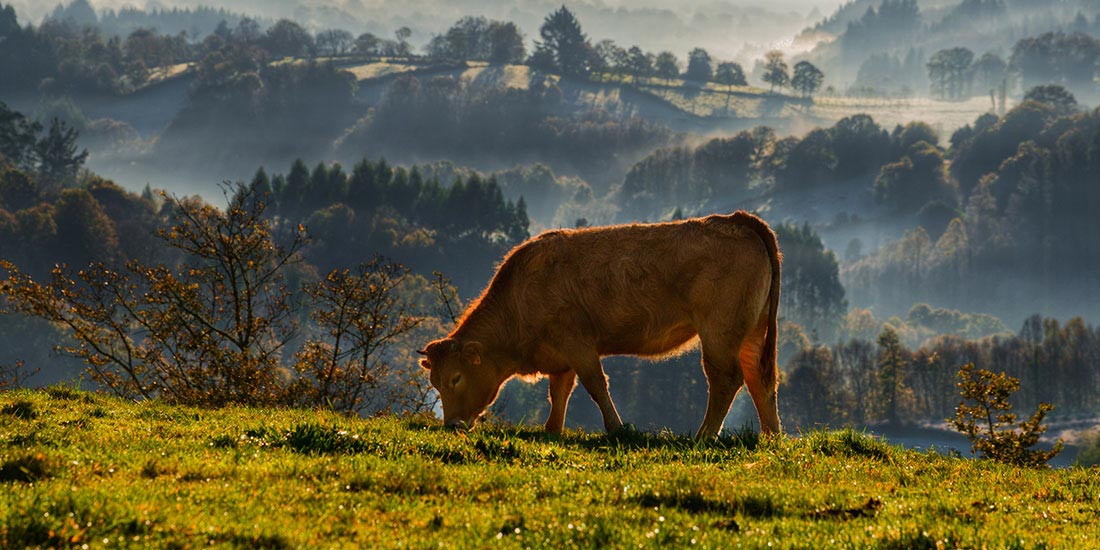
[{"left": 420, "top": 211, "right": 780, "bottom": 437}]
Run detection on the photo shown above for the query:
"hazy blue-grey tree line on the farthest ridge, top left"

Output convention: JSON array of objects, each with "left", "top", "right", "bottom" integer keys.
[{"left": 0, "top": 0, "right": 414, "bottom": 94}]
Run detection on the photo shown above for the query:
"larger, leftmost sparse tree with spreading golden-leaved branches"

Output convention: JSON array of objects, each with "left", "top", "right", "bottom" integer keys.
[{"left": 0, "top": 186, "right": 305, "bottom": 406}]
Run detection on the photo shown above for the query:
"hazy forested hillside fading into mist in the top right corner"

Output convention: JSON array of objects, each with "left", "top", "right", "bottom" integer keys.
[{"left": 802, "top": 0, "right": 1100, "bottom": 100}]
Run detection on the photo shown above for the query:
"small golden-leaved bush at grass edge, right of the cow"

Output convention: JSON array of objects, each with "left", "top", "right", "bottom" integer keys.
[{"left": 948, "top": 363, "right": 1063, "bottom": 468}]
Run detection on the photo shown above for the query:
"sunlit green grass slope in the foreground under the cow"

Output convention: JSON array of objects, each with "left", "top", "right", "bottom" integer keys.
[{"left": 0, "top": 388, "right": 1100, "bottom": 548}]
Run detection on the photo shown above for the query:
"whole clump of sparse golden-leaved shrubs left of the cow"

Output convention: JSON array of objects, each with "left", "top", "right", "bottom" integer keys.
[{"left": 0, "top": 184, "right": 435, "bottom": 413}]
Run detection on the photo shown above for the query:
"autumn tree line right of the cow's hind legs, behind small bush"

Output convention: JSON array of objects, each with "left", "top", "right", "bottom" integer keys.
[{"left": 780, "top": 315, "right": 1100, "bottom": 428}]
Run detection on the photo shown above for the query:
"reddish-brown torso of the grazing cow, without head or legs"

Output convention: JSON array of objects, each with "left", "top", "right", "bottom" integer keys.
[{"left": 482, "top": 215, "right": 771, "bottom": 355}]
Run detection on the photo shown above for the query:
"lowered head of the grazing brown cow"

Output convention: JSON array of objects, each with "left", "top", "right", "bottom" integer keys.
[{"left": 419, "top": 338, "right": 501, "bottom": 429}]
